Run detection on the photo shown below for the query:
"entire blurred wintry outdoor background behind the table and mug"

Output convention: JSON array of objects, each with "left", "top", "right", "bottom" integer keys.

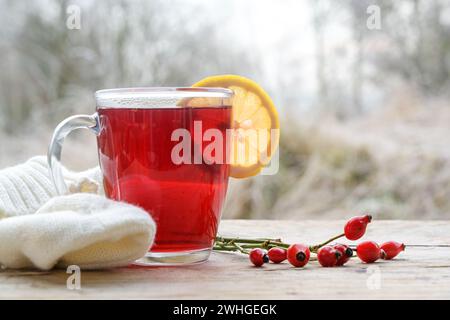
[{"left": 0, "top": 0, "right": 450, "bottom": 219}]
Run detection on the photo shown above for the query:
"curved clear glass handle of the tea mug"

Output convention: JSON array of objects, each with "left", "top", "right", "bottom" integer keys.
[{"left": 47, "top": 113, "right": 99, "bottom": 195}]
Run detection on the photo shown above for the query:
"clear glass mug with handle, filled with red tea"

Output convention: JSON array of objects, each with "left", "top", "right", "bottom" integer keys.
[{"left": 48, "top": 88, "right": 233, "bottom": 265}]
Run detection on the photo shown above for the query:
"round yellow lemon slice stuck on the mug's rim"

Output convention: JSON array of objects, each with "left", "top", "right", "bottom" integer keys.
[{"left": 193, "top": 75, "right": 280, "bottom": 178}]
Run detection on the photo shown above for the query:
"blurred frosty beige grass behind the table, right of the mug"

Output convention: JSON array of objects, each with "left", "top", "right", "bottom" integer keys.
[{"left": 226, "top": 97, "right": 450, "bottom": 219}]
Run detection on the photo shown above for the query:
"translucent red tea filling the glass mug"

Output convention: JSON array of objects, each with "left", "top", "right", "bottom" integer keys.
[{"left": 98, "top": 106, "right": 231, "bottom": 253}]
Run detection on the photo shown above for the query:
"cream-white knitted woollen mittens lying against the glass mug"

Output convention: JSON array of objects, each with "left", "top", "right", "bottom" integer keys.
[{"left": 0, "top": 157, "right": 156, "bottom": 270}]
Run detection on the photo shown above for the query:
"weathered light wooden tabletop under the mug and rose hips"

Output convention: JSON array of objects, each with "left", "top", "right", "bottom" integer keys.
[{"left": 0, "top": 220, "right": 450, "bottom": 299}]
